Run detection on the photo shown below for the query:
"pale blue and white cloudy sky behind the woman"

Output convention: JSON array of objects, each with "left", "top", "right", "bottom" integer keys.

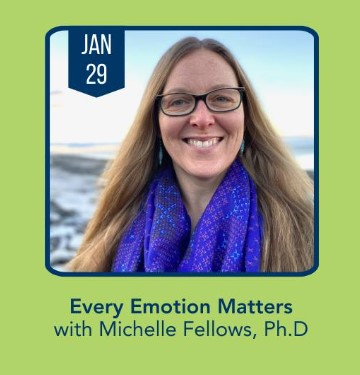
[{"left": 50, "top": 30, "right": 314, "bottom": 143}]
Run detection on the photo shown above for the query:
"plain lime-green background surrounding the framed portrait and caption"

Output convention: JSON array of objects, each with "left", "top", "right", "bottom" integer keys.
[{"left": 0, "top": 0, "right": 360, "bottom": 374}]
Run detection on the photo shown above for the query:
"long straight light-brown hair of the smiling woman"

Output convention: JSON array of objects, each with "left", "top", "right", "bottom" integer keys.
[{"left": 69, "top": 37, "right": 314, "bottom": 272}]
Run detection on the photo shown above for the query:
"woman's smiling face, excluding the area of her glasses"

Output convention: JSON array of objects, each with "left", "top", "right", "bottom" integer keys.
[{"left": 159, "top": 49, "right": 244, "bottom": 181}]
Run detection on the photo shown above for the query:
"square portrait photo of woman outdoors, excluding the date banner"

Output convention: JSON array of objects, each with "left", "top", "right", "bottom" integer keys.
[{"left": 46, "top": 26, "right": 318, "bottom": 276}]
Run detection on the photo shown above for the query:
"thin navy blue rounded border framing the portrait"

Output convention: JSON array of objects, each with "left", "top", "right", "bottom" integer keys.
[{"left": 45, "top": 25, "right": 319, "bottom": 277}]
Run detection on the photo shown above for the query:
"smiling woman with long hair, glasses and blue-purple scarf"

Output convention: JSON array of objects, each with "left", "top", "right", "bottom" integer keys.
[{"left": 70, "top": 38, "right": 313, "bottom": 272}]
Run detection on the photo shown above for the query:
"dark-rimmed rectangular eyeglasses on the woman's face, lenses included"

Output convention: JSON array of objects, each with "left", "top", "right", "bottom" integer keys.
[{"left": 156, "top": 87, "right": 245, "bottom": 116}]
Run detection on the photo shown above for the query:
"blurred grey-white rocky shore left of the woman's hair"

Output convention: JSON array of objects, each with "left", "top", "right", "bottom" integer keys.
[{"left": 49, "top": 153, "right": 107, "bottom": 271}]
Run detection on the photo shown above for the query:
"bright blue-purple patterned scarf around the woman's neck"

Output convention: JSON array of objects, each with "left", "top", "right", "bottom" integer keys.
[{"left": 112, "top": 161, "right": 262, "bottom": 272}]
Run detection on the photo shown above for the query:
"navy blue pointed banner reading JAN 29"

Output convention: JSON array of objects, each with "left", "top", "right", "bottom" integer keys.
[{"left": 69, "top": 26, "right": 125, "bottom": 97}]
